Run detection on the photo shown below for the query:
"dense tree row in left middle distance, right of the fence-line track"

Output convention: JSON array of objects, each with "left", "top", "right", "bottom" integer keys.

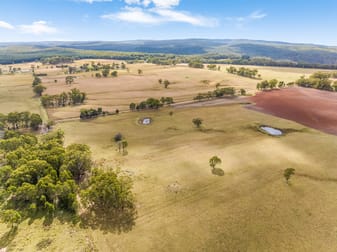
[{"left": 41, "top": 88, "right": 87, "bottom": 108}]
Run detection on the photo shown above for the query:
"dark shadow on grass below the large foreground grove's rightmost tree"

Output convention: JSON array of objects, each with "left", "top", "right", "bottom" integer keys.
[{"left": 80, "top": 208, "right": 137, "bottom": 234}]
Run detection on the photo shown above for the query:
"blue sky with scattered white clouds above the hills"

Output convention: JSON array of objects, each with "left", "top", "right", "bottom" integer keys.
[{"left": 0, "top": 0, "right": 337, "bottom": 46}]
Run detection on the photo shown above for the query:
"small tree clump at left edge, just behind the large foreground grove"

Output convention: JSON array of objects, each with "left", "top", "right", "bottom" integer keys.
[{"left": 0, "top": 111, "right": 42, "bottom": 130}]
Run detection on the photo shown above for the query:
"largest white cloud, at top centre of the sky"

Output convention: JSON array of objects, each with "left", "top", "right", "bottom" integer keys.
[{"left": 101, "top": 0, "right": 217, "bottom": 26}]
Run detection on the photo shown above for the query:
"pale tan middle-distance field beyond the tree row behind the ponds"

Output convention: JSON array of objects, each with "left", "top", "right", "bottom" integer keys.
[{"left": 28, "top": 60, "right": 334, "bottom": 120}]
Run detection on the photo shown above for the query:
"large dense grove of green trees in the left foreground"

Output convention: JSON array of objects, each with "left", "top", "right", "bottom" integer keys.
[{"left": 0, "top": 130, "right": 134, "bottom": 226}]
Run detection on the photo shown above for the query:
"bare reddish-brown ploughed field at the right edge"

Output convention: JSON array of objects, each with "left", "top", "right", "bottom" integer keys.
[{"left": 249, "top": 87, "right": 337, "bottom": 135}]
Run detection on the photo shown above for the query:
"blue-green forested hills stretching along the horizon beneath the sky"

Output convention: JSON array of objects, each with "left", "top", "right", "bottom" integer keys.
[{"left": 0, "top": 39, "right": 337, "bottom": 65}]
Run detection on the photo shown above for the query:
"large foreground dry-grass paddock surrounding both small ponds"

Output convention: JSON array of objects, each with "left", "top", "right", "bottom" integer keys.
[{"left": 1, "top": 105, "right": 337, "bottom": 251}]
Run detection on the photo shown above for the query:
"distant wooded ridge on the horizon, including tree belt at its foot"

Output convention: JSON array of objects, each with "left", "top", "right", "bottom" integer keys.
[{"left": 0, "top": 39, "right": 337, "bottom": 68}]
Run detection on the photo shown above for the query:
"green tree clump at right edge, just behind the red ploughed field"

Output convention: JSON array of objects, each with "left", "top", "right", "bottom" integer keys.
[{"left": 296, "top": 72, "right": 337, "bottom": 92}]
